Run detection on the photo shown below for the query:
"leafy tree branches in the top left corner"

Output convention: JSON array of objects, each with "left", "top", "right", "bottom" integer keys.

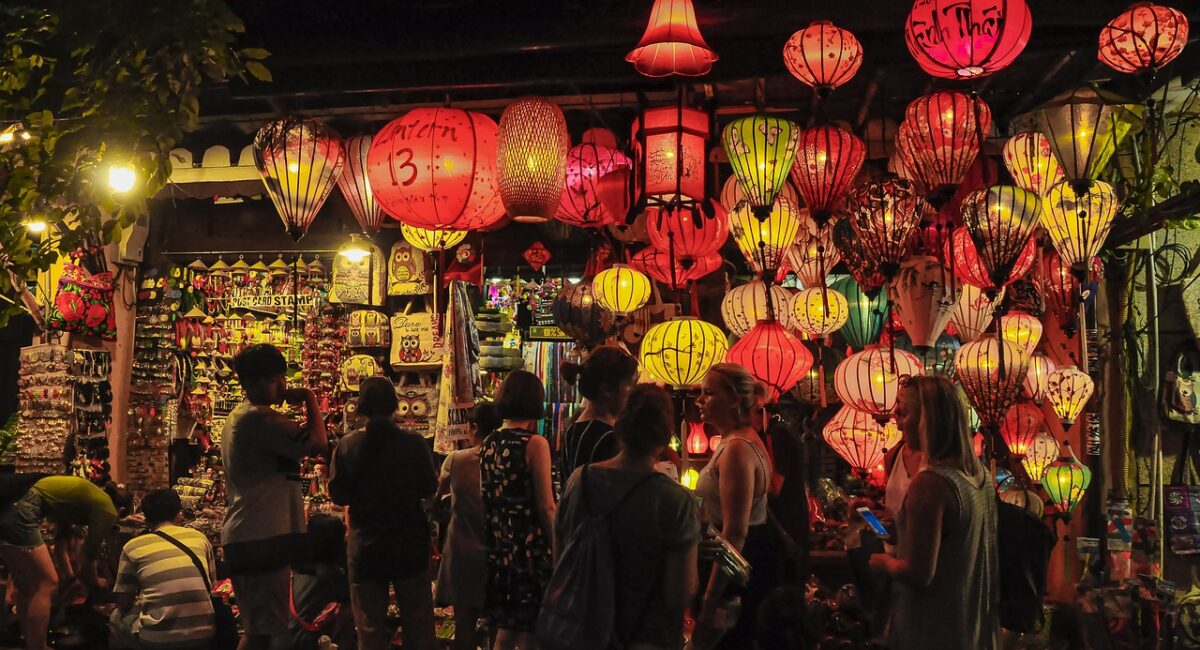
[{"left": 0, "top": 0, "right": 270, "bottom": 324}]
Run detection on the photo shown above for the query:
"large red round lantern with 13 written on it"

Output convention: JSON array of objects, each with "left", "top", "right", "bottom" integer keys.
[{"left": 367, "top": 108, "right": 504, "bottom": 230}]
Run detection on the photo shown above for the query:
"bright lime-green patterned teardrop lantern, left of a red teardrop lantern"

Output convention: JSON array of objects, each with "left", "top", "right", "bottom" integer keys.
[{"left": 721, "top": 115, "right": 800, "bottom": 221}]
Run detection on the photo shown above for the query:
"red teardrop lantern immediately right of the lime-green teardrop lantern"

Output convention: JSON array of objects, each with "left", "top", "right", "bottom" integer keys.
[{"left": 791, "top": 126, "right": 866, "bottom": 225}]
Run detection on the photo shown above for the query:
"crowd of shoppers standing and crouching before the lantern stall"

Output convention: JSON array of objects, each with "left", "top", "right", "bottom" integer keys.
[{"left": 0, "top": 345, "right": 998, "bottom": 650}]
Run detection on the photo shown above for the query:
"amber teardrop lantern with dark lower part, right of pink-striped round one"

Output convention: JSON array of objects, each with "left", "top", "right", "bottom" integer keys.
[{"left": 954, "top": 337, "right": 1030, "bottom": 427}]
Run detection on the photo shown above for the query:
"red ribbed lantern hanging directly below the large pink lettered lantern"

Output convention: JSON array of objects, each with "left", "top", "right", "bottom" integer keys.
[{"left": 896, "top": 91, "right": 991, "bottom": 200}]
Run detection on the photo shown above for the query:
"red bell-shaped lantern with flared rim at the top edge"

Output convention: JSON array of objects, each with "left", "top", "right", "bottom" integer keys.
[{"left": 625, "top": 0, "right": 716, "bottom": 77}]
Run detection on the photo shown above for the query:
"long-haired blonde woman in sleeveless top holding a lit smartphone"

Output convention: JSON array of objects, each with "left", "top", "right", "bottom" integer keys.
[{"left": 871, "top": 377, "right": 1000, "bottom": 650}]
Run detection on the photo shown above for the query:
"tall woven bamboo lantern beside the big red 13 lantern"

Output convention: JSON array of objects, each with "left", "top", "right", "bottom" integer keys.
[{"left": 496, "top": 97, "right": 571, "bottom": 223}]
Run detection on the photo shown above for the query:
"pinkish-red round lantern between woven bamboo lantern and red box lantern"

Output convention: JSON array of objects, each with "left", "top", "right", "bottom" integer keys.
[{"left": 554, "top": 132, "right": 634, "bottom": 228}]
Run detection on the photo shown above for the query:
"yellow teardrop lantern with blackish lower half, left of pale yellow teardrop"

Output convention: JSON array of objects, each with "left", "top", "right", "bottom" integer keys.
[{"left": 962, "top": 185, "right": 1042, "bottom": 287}]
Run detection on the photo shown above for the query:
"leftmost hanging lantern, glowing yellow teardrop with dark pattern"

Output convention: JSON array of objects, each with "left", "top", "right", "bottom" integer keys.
[{"left": 252, "top": 118, "right": 346, "bottom": 241}]
